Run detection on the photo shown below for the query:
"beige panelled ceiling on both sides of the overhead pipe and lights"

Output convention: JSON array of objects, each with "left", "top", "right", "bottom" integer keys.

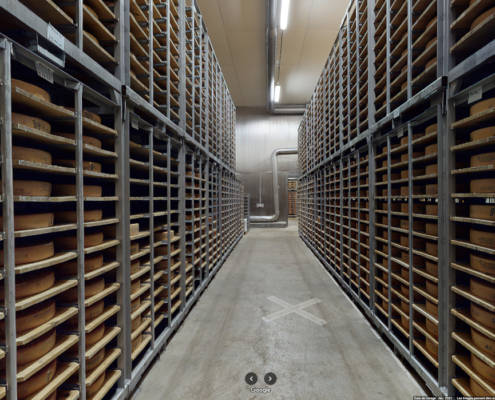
[{"left": 197, "top": 0, "right": 349, "bottom": 107}]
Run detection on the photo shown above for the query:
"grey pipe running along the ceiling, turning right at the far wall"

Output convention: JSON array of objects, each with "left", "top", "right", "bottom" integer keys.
[{"left": 266, "top": 0, "right": 306, "bottom": 114}]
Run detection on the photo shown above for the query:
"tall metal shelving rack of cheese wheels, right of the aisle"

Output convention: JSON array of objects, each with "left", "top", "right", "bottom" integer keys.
[{"left": 298, "top": 0, "right": 495, "bottom": 396}]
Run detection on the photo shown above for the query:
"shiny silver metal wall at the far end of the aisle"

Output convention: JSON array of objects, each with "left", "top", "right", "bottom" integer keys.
[{"left": 236, "top": 107, "right": 302, "bottom": 221}]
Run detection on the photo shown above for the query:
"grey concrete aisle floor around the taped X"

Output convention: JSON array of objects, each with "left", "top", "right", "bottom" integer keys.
[{"left": 134, "top": 220, "right": 423, "bottom": 400}]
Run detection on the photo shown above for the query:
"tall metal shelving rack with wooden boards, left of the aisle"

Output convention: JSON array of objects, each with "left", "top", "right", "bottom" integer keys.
[{"left": 0, "top": 0, "right": 243, "bottom": 399}]
